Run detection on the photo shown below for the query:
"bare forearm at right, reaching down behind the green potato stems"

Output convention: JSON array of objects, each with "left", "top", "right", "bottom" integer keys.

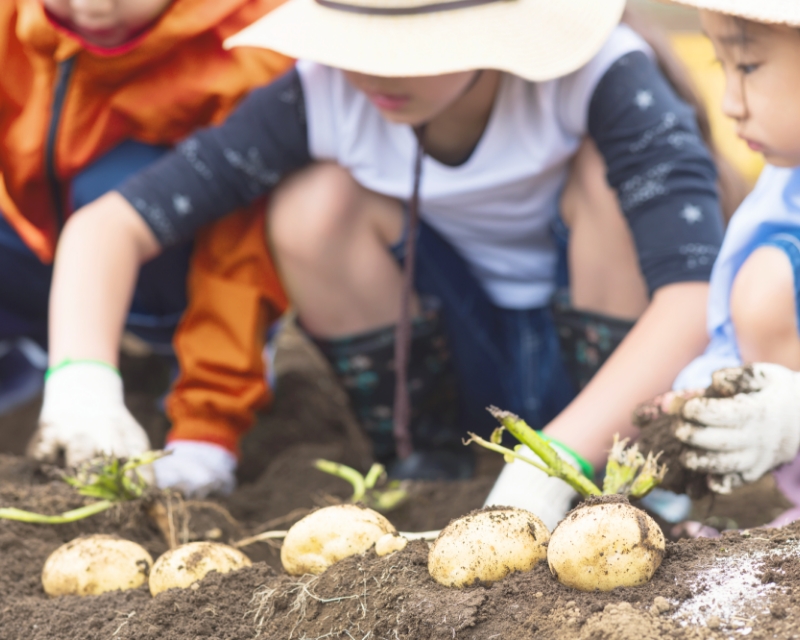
[{"left": 545, "top": 282, "right": 708, "bottom": 466}]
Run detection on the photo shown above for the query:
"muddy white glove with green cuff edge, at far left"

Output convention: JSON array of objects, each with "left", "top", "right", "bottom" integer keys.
[{"left": 28, "top": 360, "right": 150, "bottom": 470}]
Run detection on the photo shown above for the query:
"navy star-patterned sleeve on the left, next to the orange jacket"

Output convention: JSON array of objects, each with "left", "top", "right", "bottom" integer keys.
[{"left": 118, "top": 69, "right": 311, "bottom": 247}]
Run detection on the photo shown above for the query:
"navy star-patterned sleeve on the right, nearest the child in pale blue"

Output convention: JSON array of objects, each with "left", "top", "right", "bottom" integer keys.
[{"left": 589, "top": 52, "right": 723, "bottom": 295}]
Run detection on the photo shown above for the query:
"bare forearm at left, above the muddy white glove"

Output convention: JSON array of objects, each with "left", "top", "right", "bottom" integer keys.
[{"left": 49, "top": 192, "right": 160, "bottom": 366}]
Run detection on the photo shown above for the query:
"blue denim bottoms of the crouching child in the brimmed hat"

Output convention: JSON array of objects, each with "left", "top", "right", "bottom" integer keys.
[{"left": 392, "top": 222, "right": 575, "bottom": 435}]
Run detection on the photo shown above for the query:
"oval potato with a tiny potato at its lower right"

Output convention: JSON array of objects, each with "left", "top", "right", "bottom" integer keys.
[{"left": 281, "top": 504, "right": 395, "bottom": 576}]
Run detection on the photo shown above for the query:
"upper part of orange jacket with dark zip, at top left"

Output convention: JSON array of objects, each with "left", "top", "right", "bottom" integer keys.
[{"left": 0, "top": 0, "right": 291, "bottom": 262}]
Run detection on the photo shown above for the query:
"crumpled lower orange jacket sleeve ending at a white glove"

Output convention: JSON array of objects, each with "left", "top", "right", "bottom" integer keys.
[{"left": 167, "top": 201, "right": 287, "bottom": 453}]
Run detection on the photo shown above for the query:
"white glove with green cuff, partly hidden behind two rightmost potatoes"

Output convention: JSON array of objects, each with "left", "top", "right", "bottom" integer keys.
[{"left": 484, "top": 447, "right": 579, "bottom": 531}]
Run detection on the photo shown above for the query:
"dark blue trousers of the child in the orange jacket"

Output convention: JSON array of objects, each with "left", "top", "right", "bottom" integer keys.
[{"left": 0, "top": 141, "right": 192, "bottom": 353}]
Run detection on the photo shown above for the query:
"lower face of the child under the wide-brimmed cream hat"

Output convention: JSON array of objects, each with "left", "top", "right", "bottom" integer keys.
[{"left": 345, "top": 71, "right": 477, "bottom": 126}]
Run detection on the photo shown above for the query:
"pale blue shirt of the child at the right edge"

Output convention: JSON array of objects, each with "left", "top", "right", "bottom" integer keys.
[{"left": 673, "top": 166, "right": 800, "bottom": 389}]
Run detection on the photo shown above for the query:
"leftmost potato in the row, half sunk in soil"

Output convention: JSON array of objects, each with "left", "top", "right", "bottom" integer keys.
[{"left": 42, "top": 535, "right": 153, "bottom": 596}]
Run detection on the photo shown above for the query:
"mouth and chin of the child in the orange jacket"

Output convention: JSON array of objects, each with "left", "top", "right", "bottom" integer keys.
[{"left": 42, "top": 0, "right": 173, "bottom": 47}]
